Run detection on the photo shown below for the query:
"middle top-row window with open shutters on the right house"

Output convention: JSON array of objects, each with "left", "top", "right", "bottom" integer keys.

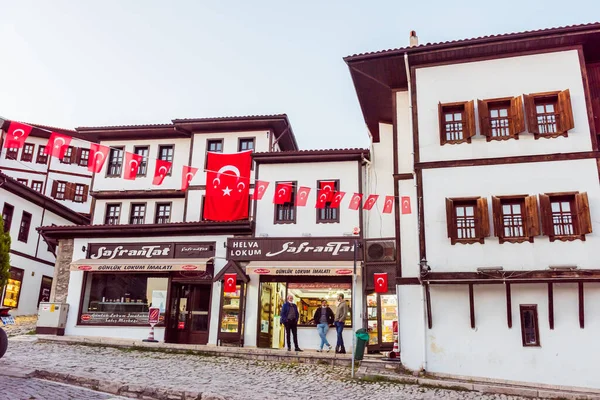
[{"left": 477, "top": 96, "right": 525, "bottom": 142}]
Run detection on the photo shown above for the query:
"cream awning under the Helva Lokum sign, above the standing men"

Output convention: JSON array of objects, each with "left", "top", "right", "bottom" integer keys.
[{"left": 246, "top": 261, "right": 361, "bottom": 276}]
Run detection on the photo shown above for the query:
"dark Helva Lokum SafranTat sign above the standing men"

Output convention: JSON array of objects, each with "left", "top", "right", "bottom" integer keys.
[{"left": 227, "top": 237, "right": 362, "bottom": 261}]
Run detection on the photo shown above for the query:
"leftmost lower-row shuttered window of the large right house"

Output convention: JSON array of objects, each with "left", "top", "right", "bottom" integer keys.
[{"left": 446, "top": 197, "right": 490, "bottom": 244}]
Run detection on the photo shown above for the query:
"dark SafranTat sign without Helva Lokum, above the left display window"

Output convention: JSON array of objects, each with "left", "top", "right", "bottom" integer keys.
[{"left": 88, "top": 242, "right": 216, "bottom": 260}]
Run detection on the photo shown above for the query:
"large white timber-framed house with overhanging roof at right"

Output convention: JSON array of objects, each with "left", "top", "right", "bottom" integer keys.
[{"left": 345, "top": 24, "right": 600, "bottom": 388}]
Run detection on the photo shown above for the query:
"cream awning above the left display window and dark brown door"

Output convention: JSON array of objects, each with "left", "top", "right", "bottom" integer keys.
[{"left": 71, "top": 258, "right": 212, "bottom": 272}]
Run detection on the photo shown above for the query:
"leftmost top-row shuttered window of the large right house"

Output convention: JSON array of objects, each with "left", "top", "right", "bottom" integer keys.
[{"left": 438, "top": 101, "right": 476, "bottom": 145}]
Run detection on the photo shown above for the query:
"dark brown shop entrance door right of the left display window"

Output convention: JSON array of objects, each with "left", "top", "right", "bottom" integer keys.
[{"left": 166, "top": 283, "right": 211, "bottom": 344}]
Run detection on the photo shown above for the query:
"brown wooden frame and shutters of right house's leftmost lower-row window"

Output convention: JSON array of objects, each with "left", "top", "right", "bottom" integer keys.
[{"left": 446, "top": 197, "right": 490, "bottom": 245}]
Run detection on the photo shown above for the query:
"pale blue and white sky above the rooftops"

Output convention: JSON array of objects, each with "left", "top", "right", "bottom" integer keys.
[{"left": 0, "top": 0, "right": 600, "bottom": 149}]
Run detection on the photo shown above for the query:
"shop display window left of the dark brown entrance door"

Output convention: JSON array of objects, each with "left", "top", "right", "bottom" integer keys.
[{"left": 79, "top": 273, "right": 169, "bottom": 326}]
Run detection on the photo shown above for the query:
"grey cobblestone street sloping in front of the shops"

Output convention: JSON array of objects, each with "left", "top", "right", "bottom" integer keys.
[{"left": 0, "top": 340, "right": 536, "bottom": 400}]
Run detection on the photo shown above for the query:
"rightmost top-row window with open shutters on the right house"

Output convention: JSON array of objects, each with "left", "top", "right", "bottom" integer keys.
[{"left": 523, "top": 89, "right": 575, "bottom": 139}]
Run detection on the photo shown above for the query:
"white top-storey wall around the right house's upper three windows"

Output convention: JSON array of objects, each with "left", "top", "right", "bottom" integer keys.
[{"left": 416, "top": 50, "right": 592, "bottom": 161}]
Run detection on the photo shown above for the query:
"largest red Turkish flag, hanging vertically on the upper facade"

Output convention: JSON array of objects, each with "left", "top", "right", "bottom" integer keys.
[{"left": 204, "top": 151, "right": 252, "bottom": 221}]
